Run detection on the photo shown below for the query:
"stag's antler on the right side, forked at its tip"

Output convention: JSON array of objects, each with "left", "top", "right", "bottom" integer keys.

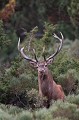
[{"left": 46, "top": 32, "right": 64, "bottom": 61}]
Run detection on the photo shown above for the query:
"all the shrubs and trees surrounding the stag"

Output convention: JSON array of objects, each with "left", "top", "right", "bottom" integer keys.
[{"left": 0, "top": 0, "right": 79, "bottom": 120}]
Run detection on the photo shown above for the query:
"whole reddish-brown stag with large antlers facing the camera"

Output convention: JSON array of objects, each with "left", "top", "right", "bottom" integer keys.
[{"left": 18, "top": 32, "right": 65, "bottom": 108}]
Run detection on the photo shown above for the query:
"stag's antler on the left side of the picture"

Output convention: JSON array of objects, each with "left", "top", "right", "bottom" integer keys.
[{"left": 18, "top": 38, "right": 38, "bottom": 63}]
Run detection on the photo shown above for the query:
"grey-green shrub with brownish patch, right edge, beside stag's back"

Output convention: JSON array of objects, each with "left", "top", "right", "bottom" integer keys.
[{"left": 57, "top": 69, "right": 79, "bottom": 94}]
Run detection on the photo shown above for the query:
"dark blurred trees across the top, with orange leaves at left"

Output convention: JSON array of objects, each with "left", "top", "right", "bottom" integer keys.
[{"left": 1, "top": 0, "right": 78, "bottom": 40}]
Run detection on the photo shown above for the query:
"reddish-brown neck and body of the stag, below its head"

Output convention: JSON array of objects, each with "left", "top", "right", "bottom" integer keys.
[{"left": 38, "top": 63, "right": 64, "bottom": 101}]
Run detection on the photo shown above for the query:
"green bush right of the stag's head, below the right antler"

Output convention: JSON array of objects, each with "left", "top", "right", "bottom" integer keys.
[{"left": 51, "top": 51, "right": 79, "bottom": 76}]
